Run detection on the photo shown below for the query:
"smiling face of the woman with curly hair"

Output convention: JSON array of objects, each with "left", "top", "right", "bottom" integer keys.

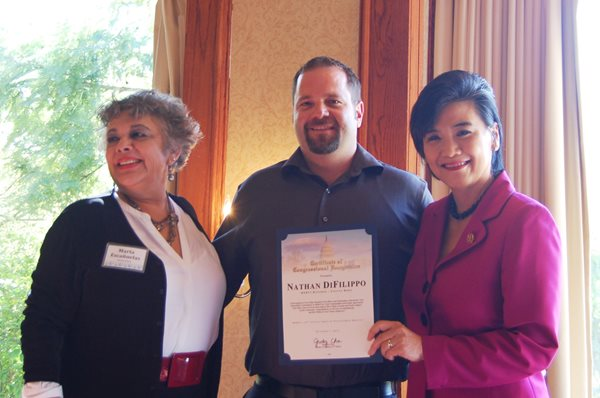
[{"left": 106, "top": 114, "right": 177, "bottom": 197}]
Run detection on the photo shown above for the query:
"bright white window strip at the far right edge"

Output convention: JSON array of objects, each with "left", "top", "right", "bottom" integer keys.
[{"left": 577, "top": 0, "right": 600, "bottom": 398}]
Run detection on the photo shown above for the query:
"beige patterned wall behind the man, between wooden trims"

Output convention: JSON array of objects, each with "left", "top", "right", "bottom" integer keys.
[{"left": 219, "top": 0, "right": 360, "bottom": 398}]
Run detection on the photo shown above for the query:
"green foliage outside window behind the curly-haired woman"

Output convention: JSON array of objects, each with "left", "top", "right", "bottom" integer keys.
[{"left": 0, "top": 0, "right": 152, "bottom": 397}]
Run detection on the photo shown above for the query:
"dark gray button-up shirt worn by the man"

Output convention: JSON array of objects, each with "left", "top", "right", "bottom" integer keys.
[{"left": 214, "top": 146, "right": 431, "bottom": 387}]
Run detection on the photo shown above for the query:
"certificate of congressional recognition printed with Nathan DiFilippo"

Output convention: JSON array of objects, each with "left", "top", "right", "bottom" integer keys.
[{"left": 279, "top": 226, "right": 381, "bottom": 363}]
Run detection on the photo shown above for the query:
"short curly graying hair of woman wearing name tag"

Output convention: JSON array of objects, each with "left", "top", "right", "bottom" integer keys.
[{"left": 98, "top": 90, "right": 202, "bottom": 171}]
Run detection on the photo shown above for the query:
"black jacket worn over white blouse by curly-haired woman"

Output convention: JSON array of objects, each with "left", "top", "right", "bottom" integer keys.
[{"left": 21, "top": 191, "right": 223, "bottom": 398}]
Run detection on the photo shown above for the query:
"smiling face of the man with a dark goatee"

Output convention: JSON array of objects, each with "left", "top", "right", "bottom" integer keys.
[{"left": 294, "top": 67, "right": 364, "bottom": 156}]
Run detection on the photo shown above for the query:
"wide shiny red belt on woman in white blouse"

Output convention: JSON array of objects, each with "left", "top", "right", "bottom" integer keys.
[{"left": 160, "top": 351, "right": 206, "bottom": 388}]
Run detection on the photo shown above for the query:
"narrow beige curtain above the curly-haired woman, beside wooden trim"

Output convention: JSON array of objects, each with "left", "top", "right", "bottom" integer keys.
[{"left": 152, "top": 0, "right": 186, "bottom": 97}]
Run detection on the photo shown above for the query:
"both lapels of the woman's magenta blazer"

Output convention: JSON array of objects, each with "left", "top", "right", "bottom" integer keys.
[{"left": 432, "top": 171, "right": 515, "bottom": 272}]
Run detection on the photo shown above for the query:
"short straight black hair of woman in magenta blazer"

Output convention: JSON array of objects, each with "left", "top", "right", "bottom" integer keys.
[{"left": 410, "top": 70, "right": 504, "bottom": 176}]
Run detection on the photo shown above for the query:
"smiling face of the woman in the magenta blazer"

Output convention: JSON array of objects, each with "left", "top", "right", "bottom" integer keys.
[{"left": 423, "top": 101, "right": 500, "bottom": 197}]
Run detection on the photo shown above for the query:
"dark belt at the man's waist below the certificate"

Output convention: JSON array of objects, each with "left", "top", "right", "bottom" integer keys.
[{"left": 255, "top": 375, "right": 396, "bottom": 398}]
